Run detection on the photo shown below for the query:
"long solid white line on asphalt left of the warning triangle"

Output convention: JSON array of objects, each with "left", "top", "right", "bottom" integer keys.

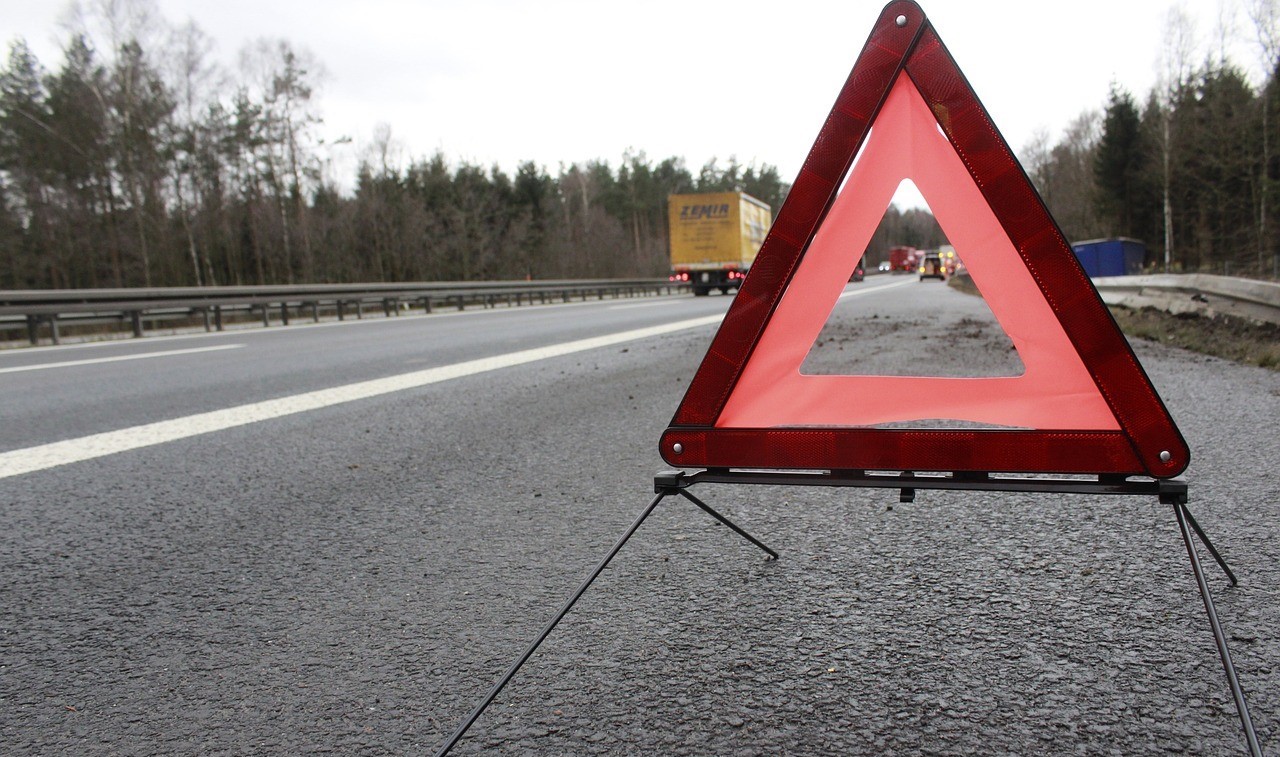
[{"left": 0, "top": 315, "right": 724, "bottom": 479}]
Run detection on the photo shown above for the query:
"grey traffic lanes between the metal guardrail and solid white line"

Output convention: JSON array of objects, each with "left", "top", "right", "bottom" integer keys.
[{"left": 0, "top": 282, "right": 921, "bottom": 461}]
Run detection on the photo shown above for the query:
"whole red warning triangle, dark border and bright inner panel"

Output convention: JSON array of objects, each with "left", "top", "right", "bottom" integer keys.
[{"left": 660, "top": 0, "right": 1190, "bottom": 478}]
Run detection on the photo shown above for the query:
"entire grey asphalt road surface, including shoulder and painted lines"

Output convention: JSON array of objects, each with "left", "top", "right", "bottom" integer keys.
[{"left": 0, "top": 277, "right": 1280, "bottom": 754}]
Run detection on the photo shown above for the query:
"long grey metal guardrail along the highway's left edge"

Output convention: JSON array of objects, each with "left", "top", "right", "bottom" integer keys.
[{"left": 0, "top": 279, "right": 687, "bottom": 345}]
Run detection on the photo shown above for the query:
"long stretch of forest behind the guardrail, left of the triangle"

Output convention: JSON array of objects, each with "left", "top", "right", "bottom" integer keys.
[{"left": 0, "top": 0, "right": 788, "bottom": 289}]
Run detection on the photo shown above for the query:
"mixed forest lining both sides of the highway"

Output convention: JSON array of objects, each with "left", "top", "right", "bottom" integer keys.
[{"left": 0, "top": 0, "right": 1280, "bottom": 289}]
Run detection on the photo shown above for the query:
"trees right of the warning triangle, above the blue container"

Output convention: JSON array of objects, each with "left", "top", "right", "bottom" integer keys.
[{"left": 1021, "top": 0, "right": 1280, "bottom": 278}]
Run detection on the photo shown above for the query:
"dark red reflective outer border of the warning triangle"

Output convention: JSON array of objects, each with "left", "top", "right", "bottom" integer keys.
[{"left": 659, "top": 0, "right": 1190, "bottom": 478}]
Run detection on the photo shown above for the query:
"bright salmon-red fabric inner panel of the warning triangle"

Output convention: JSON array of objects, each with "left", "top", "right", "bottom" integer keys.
[{"left": 716, "top": 74, "right": 1120, "bottom": 430}]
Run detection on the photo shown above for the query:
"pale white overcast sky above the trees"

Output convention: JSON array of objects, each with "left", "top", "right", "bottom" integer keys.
[{"left": 0, "top": 0, "right": 1257, "bottom": 195}]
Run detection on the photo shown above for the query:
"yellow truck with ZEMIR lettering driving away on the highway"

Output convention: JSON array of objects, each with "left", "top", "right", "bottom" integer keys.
[{"left": 667, "top": 192, "right": 773, "bottom": 296}]
